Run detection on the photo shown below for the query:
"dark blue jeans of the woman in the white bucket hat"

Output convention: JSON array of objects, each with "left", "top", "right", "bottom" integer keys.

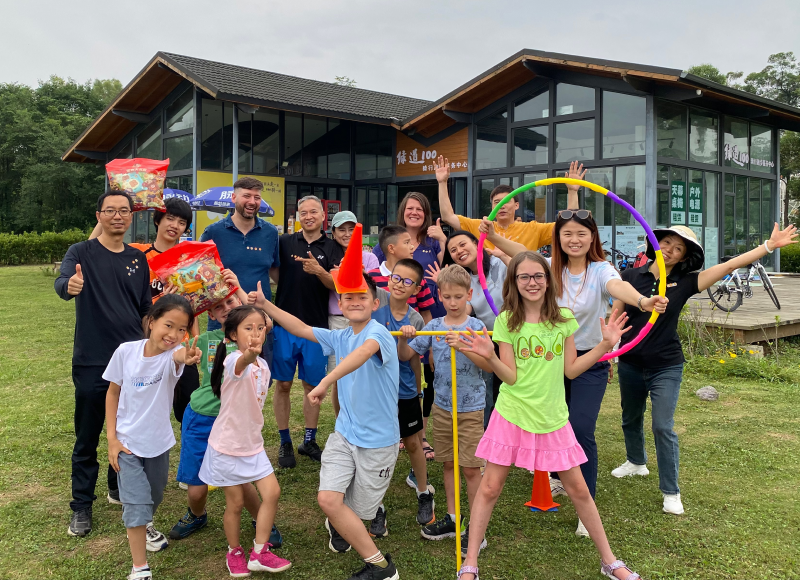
[{"left": 617, "top": 361, "right": 683, "bottom": 494}]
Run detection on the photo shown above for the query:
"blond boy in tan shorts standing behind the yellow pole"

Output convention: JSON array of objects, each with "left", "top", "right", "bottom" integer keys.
[{"left": 398, "top": 265, "right": 489, "bottom": 555}]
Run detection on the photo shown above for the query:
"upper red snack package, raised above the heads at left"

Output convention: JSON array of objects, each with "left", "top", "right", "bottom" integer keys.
[{"left": 106, "top": 158, "right": 169, "bottom": 211}]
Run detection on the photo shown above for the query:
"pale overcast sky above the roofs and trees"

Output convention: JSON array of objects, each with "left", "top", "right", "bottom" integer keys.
[{"left": 6, "top": 0, "right": 800, "bottom": 100}]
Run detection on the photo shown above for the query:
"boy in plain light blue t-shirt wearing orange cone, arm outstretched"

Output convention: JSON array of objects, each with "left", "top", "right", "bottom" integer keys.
[{"left": 254, "top": 274, "right": 400, "bottom": 580}]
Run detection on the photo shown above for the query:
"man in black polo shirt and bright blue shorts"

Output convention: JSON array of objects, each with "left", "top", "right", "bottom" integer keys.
[{"left": 272, "top": 195, "right": 344, "bottom": 467}]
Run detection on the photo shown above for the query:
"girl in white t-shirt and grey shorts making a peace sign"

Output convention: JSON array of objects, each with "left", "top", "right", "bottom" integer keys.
[{"left": 103, "top": 294, "right": 200, "bottom": 580}]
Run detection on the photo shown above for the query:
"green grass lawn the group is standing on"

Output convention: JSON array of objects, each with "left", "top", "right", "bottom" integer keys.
[{"left": 0, "top": 267, "right": 800, "bottom": 580}]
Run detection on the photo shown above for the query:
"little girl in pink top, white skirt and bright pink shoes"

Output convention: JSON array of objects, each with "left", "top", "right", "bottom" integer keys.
[{"left": 199, "top": 306, "right": 292, "bottom": 578}]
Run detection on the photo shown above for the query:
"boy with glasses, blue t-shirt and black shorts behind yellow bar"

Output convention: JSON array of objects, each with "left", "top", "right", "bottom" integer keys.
[{"left": 370, "top": 259, "right": 435, "bottom": 537}]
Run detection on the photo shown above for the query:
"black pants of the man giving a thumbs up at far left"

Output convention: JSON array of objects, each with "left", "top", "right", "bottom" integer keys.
[{"left": 69, "top": 366, "right": 119, "bottom": 511}]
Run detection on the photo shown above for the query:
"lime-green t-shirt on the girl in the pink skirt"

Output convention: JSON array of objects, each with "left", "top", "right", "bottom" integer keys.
[{"left": 492, "top": 308, "right": 578, "bottom": 433}]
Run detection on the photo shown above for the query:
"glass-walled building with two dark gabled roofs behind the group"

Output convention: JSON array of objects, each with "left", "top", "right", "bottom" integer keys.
[{"left": 62, "top": 49, "right": 800, "bottom": 268}]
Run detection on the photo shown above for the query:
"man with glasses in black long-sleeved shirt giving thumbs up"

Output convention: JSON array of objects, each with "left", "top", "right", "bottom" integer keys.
[{"left": 55, "top": 191, "right": 151, "bottom": 536}]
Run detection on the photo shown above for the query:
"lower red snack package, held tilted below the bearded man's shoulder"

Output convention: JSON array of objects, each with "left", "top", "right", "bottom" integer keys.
[{"left": 149, "top": 242, "right": 238, "bottom": 315}]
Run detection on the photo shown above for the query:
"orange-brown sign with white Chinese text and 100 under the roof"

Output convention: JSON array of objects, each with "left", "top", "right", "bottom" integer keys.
[{"left": 395, "top": 128, "right": 469, "bottom": 177}]
